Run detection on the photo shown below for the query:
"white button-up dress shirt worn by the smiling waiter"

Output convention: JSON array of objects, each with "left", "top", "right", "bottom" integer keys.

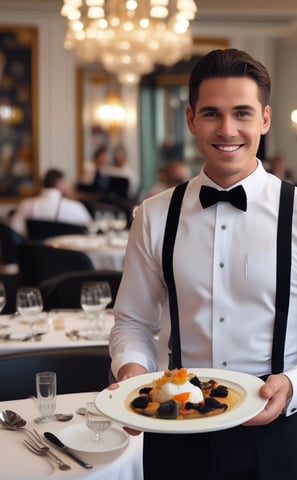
[{"left": 110, "top": 162, "right": 297, "bottom": 413}]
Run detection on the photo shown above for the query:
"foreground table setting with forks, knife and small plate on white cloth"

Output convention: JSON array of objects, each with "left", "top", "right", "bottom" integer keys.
[{"left": 0, "top": 390, "right": 143, "bottom": 480}]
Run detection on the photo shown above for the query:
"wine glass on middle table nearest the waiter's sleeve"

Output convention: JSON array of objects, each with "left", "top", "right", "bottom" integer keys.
[{"left": 80, "top": 282, "right": 112, "bottom": 339}]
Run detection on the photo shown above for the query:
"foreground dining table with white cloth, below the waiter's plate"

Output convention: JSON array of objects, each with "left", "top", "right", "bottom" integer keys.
[{"left": 0, "top": 392, "right": 143, "bottom": 480}]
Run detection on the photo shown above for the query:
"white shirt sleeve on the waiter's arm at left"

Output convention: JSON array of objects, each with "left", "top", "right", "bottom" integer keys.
[{"left": 109, "top": 201, "right": 166, "bottom": 377}]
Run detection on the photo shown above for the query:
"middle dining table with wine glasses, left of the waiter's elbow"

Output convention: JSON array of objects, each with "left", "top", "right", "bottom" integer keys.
[{"left": 0, "top": 309, "right": 114, "bottom": 357}]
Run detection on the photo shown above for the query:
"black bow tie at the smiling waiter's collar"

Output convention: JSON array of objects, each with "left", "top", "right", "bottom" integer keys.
[{"left": 199, "top": 185, "right": 247, "bottom": 212}]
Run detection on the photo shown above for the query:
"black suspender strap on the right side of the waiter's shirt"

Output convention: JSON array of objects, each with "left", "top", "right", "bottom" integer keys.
[{"left": 271, "top": 181, "right": 295, "bottom": 373}]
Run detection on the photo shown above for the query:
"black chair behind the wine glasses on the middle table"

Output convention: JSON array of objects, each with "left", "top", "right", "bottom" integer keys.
[{"left": 39, "top": 270, "right": 122, "bottom": 310}]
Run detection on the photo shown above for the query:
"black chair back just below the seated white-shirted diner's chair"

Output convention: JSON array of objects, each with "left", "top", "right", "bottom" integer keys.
[{"left": 17, "top": 243, "right": 94, "bottom": 286}]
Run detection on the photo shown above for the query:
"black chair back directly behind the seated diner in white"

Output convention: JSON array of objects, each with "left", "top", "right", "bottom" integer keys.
[{"left": 26, "top": 218, "right": 86, "bottom": 241}]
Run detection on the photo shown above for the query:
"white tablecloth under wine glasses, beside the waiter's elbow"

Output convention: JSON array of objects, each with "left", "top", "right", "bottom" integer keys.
[{"left": 0, "top": 310, "right": 114, "bottom": 355}]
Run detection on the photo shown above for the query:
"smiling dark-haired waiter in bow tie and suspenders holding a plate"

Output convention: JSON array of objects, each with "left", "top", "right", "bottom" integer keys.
[{"left": 110, "top": 49, "right": 297, "bottom": 480}]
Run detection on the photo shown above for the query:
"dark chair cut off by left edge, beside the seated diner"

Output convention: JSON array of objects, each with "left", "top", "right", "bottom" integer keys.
[{"left": 0, "top": 221, "right": 26, "bottom": 267}]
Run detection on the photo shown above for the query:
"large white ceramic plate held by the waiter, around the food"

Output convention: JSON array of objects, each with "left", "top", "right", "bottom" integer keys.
[{"left": 95, "top": 368, "right": 267, "bottom": 433}]
